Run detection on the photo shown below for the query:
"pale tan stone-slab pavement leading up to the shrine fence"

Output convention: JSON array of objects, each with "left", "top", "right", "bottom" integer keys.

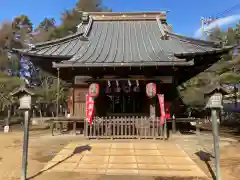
[{"left": 43, "top": 141, "right": 207, "bottom": 177}]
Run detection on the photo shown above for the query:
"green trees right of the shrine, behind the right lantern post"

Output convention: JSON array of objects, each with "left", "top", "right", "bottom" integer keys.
[{"left": 180, "top": 24, "right": 240, "bottom": 106}]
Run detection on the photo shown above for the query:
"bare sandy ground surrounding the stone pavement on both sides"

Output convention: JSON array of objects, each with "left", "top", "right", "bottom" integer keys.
[{"left": 0, "top": 127, "right": 240, "bottom": 180}]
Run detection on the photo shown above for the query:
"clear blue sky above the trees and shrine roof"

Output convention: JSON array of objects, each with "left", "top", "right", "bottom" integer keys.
[{"left": 0, "top": 0, "right": 240, "bottom": 36}]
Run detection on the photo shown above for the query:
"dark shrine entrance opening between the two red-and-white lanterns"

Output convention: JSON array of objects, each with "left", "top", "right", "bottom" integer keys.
[{"left": 96, "top": 80, "right": 149, "bottom": 117}]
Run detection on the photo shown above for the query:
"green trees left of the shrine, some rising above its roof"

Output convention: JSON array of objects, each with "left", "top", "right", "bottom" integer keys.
[{"left": 0, "top": 0, "right": 111, "bottom": 109}]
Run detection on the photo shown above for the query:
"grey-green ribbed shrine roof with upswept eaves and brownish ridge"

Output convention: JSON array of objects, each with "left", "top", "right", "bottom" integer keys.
[{"left": 12, "top": 13, "right": 232, "bottom": 67}]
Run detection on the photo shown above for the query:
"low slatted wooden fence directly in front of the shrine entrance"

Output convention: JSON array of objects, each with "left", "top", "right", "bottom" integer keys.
[{"left": 84, "top": 117, "right": 167, "bottom": 139}]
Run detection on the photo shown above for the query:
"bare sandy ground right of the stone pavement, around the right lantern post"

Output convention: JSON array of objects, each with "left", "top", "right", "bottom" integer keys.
[{"left": 174, "top": 132, "right": 240, "bottom": 180}]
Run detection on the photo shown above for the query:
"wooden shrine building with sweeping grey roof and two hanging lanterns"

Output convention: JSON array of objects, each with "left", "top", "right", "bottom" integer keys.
[{"left": 12, "top": 12, "right": 230, "bottom": 138}]
